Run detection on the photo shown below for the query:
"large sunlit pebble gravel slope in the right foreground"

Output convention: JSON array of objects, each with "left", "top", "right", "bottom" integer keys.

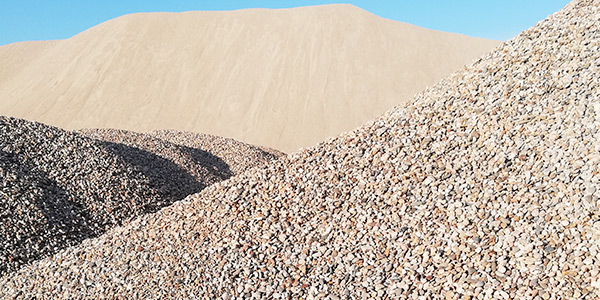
[{"left": 0, "top": 0, "right": 600, "bottom": 299}]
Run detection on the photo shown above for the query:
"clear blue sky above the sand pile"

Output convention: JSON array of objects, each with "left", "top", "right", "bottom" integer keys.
[{"left": 0, "top": 0, "right": 569, "bottom": 45}]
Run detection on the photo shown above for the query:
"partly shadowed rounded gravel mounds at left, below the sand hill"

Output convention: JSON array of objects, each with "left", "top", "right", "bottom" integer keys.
[{"left": 0, "top": 117, "right": 277, "bottom": 274}]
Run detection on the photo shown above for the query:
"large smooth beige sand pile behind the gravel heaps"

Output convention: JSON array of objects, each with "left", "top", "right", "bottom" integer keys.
[{"left": 0, "top": 5, "right": 500, "bottom": 152}]
